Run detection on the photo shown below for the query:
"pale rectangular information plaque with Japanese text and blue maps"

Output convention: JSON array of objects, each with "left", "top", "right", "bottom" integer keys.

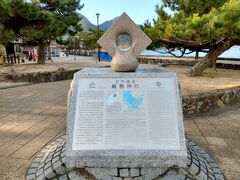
[{"left": 72, "top": 78, "right": 181, "bottom": 150}]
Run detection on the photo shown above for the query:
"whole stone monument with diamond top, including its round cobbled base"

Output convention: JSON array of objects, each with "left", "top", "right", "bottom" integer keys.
[{"left": 27, "top": 13, "right": 224, "bottom": 180}]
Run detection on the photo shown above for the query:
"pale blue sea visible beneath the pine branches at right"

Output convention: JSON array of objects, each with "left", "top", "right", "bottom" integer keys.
[{"left": 141, "top": 46, "right": 240, "bottom": 60}]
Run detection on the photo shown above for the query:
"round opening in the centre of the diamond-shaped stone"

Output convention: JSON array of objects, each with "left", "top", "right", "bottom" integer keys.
[{"left": 116, "top": 33, "right": 132, "bottom": 51}]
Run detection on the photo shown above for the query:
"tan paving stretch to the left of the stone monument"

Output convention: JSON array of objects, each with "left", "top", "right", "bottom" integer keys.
[{"left": 0, "top": 81, "right": 70, "bottom": 180}]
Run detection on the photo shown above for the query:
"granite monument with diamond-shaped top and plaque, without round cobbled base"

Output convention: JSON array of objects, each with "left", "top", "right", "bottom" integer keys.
[{"left": 66, "top": 13, "right": 187, "bottom": 179}]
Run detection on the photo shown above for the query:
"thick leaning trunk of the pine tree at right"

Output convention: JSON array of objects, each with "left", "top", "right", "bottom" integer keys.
[{"left": 188, "top": 40, "right": 233, "bottom": 77}]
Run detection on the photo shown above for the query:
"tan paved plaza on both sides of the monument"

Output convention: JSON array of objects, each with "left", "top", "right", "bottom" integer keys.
[{"left": 0, "top": 81, "right": 240, "bottom": 180}]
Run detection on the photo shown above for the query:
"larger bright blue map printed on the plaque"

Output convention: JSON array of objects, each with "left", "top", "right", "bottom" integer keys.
[{"left": 123, "top": 91, "right": 143, "bottom": 110}]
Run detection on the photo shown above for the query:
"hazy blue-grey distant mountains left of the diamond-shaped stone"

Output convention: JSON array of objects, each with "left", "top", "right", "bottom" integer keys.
[{"left": 81, "top": 15, "right": 118, "bottom": 31}]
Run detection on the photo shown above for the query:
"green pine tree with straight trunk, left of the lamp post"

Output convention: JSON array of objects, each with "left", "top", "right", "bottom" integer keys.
[{"left": 0, "top": 0, "right": 83, "bottom": 64}]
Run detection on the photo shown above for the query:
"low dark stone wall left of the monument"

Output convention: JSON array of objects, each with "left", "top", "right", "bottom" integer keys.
[{"left": 5, "top": 69, "right": 80, "bottom": 83}]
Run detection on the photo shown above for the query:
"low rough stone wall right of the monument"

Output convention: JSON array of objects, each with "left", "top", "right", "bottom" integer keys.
[{"left": 183, "top": 86, "right": 240, "bottom": 114}]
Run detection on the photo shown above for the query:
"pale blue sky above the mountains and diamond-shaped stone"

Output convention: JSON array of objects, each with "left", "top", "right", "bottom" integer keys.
[{"left": 80, "top": 0, "right": 161, "bottom": 24}]
